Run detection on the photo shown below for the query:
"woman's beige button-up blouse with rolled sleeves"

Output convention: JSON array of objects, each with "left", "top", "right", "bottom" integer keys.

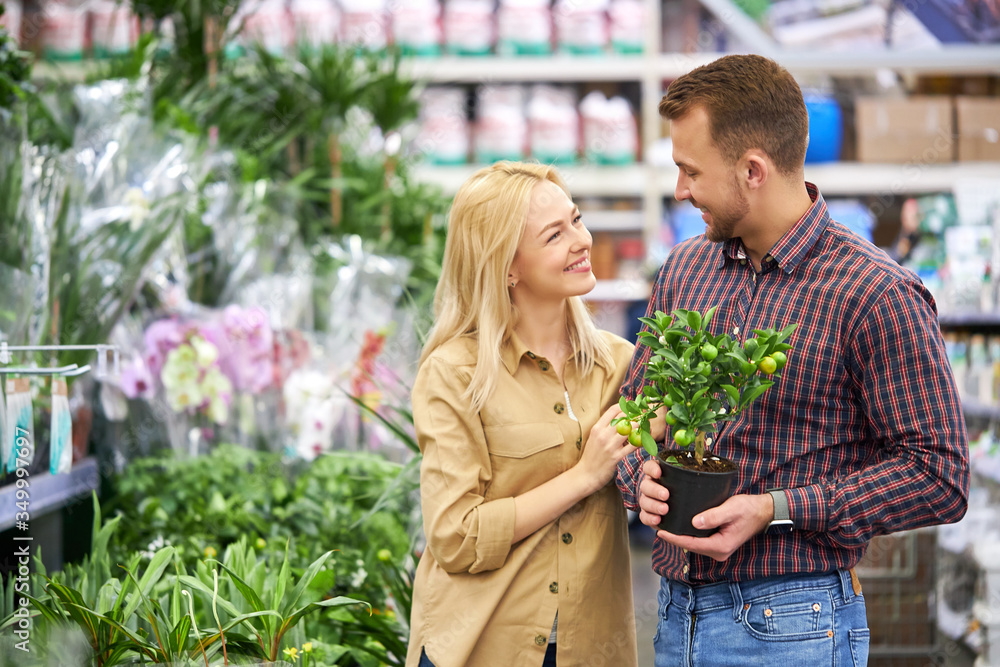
[{"left": 406, "top": 332, "right": 637, "bottom": 667}]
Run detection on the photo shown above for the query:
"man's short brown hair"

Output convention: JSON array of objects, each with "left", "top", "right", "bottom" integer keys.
[{"left": 660, "top": 55, "right": 809, "bottom": 176}]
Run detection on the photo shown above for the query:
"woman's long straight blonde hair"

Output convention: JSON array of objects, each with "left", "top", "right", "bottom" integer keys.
[{"left": 420, "top": 162, "right": 612, "bottom": 412}]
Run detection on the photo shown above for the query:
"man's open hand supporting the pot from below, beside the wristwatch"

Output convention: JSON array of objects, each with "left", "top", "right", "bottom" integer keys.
[{"left": 660, "top": 494, "right": 774, "bottom": 561}]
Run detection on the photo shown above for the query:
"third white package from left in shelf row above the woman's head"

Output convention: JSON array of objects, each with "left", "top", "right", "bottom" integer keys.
[{"left": 528, "top": 85, "right": 580, "bottom": 164}]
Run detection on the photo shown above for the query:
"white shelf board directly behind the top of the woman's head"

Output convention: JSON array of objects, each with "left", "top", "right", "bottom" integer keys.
[{"left": 415, "top": 164, "right": 646, "bottom": 197}]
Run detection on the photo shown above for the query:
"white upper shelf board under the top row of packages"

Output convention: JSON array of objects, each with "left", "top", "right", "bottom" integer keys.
[{"left": 405, "top": 54, "right": 650, "bottom": 84}]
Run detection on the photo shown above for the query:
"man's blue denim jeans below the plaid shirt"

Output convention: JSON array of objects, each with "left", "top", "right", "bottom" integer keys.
[{"left": 653, "top": 570, "right": 870, "bottom": 667}]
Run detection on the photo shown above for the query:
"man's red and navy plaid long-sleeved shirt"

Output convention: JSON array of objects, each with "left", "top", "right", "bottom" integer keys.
[{"left": 617, "top": 183, "right": 969, "bottom": 583}]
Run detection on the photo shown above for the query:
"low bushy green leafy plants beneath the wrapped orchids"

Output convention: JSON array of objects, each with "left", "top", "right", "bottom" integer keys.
[{"left": 108, "top": 446, "right": 418, "bottom": 607}]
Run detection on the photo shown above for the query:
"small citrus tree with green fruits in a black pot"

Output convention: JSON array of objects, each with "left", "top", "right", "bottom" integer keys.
[{"left": 615, "top": 307, "right": 798, "bottom": 537}]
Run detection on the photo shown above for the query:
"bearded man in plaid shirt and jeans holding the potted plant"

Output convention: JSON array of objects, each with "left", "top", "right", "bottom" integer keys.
[{"left": 617, "top": 55, "right": 969, "bottom": 667}]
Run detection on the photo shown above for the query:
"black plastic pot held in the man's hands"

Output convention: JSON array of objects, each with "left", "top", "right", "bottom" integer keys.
[{"left": 656, "top": 458, "right": 737, "bottom": 537}]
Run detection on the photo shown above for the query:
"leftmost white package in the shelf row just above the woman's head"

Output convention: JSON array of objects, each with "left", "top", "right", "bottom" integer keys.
[{"left": 415, "top": 86, "right": 470, "bottom": 164}]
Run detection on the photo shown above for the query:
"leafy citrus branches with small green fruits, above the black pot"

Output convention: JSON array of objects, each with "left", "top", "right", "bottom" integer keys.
[{"left": 616, "top": 307, "right": 798, "bottom": 463}]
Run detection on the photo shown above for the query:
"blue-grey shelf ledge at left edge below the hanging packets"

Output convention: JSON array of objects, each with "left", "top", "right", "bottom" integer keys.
[{"left": 0, "top": 456, "right": 100, "bottom": 530}]
